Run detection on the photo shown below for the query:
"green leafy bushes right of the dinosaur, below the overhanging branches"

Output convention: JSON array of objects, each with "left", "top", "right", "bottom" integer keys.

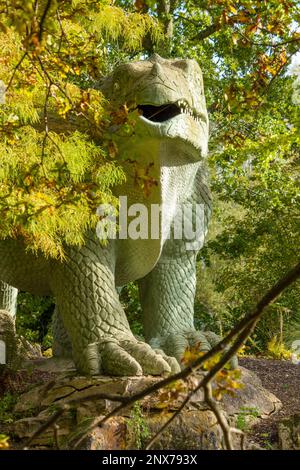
[{"left": 199, "top": 92, "right": 300, "bottom": 348}]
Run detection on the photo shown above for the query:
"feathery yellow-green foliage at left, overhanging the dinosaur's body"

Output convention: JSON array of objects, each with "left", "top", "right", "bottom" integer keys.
[{"left": 0, "top": 0, "right": 160, "bottom": 258}]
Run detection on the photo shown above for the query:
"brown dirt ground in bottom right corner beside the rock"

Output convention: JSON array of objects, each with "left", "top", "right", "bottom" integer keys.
[{"left": 239, "top": 358, "right": 300, "bottom": 449}]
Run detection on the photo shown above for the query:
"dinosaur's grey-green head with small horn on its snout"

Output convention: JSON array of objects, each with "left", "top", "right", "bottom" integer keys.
[{"left": 101, "top": 54, "right": 208, "bottom": 156}]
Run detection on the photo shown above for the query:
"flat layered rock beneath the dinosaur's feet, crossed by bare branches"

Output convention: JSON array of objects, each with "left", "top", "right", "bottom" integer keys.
[{"left": 11, "top": 359, "right": 280, "bottom": 450}]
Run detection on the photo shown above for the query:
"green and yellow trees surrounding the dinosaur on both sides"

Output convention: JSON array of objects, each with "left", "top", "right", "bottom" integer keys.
[{"left": 0, "top": 0, "right": 300, "bottom": 350}]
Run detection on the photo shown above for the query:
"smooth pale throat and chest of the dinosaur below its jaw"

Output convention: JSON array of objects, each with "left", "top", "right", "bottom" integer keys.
[{"left": 116, "top": 134, "right": 201, "bottom": 285}]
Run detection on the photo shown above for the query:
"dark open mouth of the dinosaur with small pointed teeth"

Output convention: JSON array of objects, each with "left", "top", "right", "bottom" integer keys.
[{"left": 138, "top": 100, "right": 200, "bottom": 122}]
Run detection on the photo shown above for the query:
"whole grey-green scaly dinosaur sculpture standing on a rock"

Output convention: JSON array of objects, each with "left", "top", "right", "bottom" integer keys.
[{"left": 0, "top": 54, "right": 217, "bottom": 375}]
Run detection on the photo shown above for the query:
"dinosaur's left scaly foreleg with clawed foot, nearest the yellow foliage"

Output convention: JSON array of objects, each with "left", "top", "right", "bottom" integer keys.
[{"left": 52, "top": 236, "right": 175, "bottom": 375}]
